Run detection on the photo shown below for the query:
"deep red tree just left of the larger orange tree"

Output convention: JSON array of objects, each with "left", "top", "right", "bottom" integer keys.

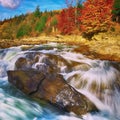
[{"left": 58, "top": 0, "right": 83, "bottom": 34}]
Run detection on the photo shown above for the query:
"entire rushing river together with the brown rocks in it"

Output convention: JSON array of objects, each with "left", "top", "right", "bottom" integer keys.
[{"left": 0, "top": 43, "right": 120, "bottom": 120}]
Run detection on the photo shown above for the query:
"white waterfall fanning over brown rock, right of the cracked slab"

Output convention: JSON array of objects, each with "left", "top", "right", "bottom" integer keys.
[{"left": 64, "top": 53, "right": 120, "bottom": 115}]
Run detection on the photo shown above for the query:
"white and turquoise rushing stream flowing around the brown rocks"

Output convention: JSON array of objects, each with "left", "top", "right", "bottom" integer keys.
[{"left": 0, "top": 43, "right": 120, "bottom": 120}]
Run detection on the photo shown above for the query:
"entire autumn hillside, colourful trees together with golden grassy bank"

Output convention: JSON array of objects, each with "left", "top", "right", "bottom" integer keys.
[{"left": 0, "top": 0, "right": 120, "bottom": 61}]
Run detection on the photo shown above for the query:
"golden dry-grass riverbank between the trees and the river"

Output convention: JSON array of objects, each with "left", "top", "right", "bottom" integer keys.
[{"left": 0, "top": 33, "right": 120, "bottom": 62}]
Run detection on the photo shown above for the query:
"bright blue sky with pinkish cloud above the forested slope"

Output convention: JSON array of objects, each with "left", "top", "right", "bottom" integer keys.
[{"left": 0, "top": 0, "right": 66, "bottom": 20}]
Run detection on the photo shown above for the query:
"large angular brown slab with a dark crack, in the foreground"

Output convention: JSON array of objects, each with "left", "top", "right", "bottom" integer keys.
[{"left": 8, "top": 70, "right": 97, "bottom": 115}]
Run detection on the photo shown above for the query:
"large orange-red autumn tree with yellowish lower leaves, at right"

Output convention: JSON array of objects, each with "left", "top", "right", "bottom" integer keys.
[{"left": 79, "top": 0, "right": 113, "bottom": 38}]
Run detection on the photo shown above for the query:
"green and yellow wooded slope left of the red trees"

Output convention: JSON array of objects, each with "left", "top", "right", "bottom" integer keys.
[{"left": 0, "top": 7, "right": 59, "bottom": 39}]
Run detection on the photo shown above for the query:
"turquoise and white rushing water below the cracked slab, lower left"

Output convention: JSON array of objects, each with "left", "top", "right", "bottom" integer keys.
[{"left": 0, "top": 79, "right": 58, "bottom": 120}]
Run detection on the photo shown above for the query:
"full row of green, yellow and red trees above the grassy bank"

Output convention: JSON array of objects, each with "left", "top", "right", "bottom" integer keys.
[{"left": 0, "top": 0, "right": 120, "bottom": 39}]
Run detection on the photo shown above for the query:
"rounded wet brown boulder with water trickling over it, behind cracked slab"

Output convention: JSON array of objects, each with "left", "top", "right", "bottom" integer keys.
[{"left": 15, "top": 52, "right": 73, "bottom": 74}]
